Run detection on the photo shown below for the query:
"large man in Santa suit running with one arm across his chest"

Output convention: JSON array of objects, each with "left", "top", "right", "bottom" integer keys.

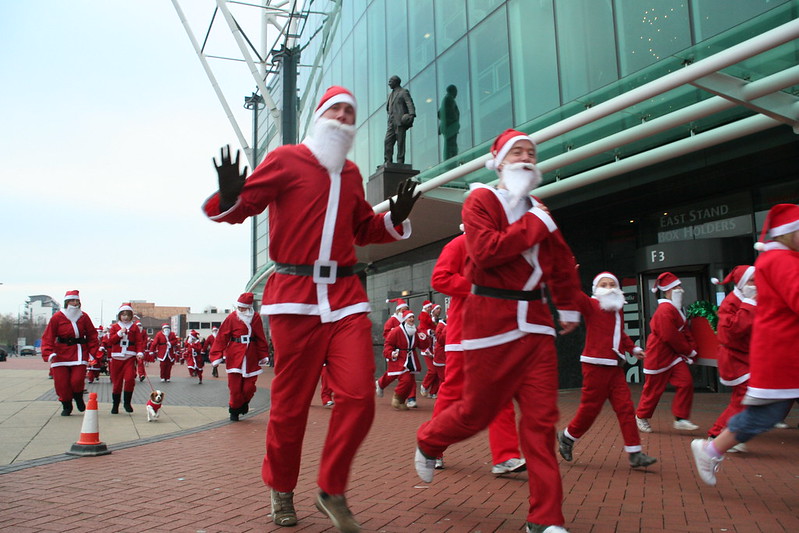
[{"left": 414, "top": 130, "right": 580, "bottom": 532}]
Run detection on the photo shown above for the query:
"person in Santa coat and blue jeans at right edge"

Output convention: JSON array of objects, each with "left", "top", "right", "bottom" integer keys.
[{"left": 691, "top": 204, "right": 799, "bottom": 485}]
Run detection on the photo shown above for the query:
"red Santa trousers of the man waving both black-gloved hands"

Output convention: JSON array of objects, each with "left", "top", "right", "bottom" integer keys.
[{"left": 261, "top": 313, "right": 375, "bottom": 494}]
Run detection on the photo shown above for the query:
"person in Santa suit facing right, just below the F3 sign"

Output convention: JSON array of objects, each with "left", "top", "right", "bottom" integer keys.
[{"left": 635, "top": 272, "right": 699, "bottom": 433}]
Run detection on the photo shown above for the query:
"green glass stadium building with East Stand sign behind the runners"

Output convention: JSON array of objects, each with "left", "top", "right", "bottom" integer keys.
[{"left": 253, "top": 0, "right": 799, "bottom": 386}]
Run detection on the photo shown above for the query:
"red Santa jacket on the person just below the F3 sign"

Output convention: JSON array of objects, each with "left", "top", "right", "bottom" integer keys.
[{"left": 644, "top": 298, "right": 696, "bottom": 374}]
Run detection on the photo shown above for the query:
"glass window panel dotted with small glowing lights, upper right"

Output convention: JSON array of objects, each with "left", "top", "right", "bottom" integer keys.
[{"left": 616, "top": 0, "right": 691, "bottom": 76}]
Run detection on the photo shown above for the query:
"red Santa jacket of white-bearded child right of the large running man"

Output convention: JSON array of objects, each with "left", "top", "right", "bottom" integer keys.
[{"left": 579, "top": 293, "right": 641, "bottom": 366}]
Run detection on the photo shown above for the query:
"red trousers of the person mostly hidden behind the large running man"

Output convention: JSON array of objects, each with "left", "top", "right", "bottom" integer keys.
[{"left": 433, "top": 350, "right": 522, "bottom": 465}]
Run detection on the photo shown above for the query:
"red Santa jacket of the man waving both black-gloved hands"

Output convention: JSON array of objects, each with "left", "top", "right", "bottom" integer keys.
[{"left": 203, "top": 144, "right": 411, "bottom": 322}]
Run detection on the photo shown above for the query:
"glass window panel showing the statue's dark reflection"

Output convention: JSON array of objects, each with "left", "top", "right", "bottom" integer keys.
[{"left": 436, "top": 39, "right": 472, "bottom": 160}]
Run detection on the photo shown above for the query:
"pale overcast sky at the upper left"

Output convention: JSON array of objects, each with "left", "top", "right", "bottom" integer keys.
[{"left": 0, "top": 0, "right": 268, "bottom": 323}]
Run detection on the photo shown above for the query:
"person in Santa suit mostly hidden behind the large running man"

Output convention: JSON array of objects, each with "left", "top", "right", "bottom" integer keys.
[{"left": 422, "top": 235, "right": 527, "bottom": 475}]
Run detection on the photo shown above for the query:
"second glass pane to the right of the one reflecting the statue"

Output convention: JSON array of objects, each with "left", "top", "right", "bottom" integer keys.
[{"left": 508, "top": 0, "right": 560, "bottom": 124}]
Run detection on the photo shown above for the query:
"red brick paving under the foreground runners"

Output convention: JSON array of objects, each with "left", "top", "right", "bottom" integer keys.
[{"left": 0, "top": 364, "right": 799, "bottom": 533}]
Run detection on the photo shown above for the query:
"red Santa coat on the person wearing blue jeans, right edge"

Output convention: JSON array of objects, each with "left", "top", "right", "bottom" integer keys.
[{"left": 746, "top": 242, "right": 799, "bottom": 400}]
